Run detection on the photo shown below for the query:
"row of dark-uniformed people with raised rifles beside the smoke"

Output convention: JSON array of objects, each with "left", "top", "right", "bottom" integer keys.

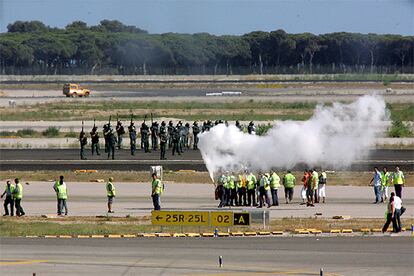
[{"left": 79, "top": 119, "right": 256, "bottom": 160}]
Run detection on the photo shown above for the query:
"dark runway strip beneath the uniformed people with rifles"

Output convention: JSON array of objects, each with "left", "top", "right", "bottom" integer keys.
[{"left": 0, "top": 148, "right": 414, "bottom": 171}]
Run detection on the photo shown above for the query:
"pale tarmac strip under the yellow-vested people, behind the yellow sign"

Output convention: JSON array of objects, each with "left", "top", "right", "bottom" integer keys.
[{"left": 2, "top": 182, "right": 414, "bottom": 219}]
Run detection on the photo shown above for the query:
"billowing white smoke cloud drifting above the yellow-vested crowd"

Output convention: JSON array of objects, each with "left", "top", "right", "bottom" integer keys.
[{"left": 198, "top": 95, "right": 389, "bottom": 177}]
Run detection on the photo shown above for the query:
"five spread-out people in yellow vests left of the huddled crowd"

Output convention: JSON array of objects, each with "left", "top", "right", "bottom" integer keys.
[{"left": 1, "top": 173, "right": 164, "bottom": 217}]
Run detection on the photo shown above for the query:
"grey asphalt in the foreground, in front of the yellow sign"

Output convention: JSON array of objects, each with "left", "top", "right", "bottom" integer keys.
[{"left": 0, "top": 236, "right": 414, "bottom": 276}]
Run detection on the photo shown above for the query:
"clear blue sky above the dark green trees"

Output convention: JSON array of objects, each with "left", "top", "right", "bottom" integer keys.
[{"left": 0, "top": 0, "right": 414, "bottom": 35}]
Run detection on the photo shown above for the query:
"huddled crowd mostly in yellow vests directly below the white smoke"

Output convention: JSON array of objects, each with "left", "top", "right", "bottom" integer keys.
[{"left": 215, "top": 170, "right": 327, "bottom": 208}]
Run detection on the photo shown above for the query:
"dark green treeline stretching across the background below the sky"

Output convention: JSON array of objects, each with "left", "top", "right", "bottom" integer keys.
[{"left": 0, "top": 20, "right": 414, "bottom": 75}]
